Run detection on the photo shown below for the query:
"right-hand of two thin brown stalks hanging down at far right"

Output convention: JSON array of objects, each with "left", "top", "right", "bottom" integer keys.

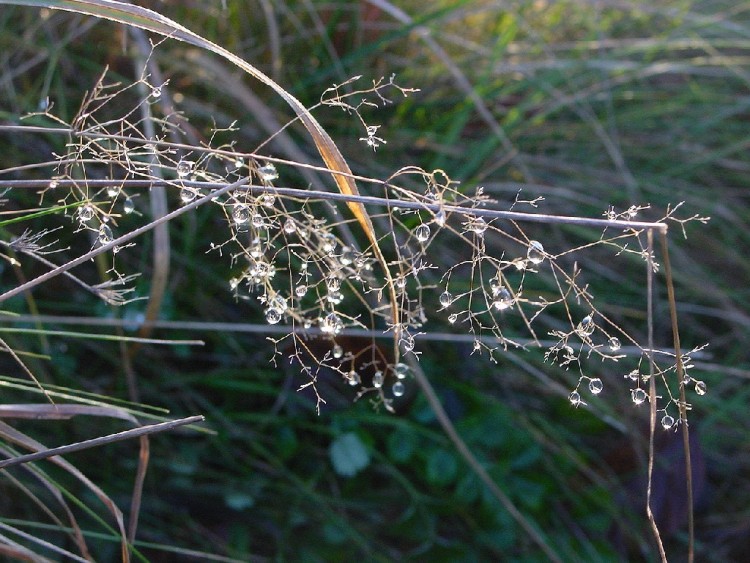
[{"left": 661, "top": 232, "right": 695, "bottom": 563}]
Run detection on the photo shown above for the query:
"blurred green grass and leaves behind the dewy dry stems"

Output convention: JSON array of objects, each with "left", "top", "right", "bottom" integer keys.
[{"left": 0, "top": 0, "right": 750, "bottom": 561}]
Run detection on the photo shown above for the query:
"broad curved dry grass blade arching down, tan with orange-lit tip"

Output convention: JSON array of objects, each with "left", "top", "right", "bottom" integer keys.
[{"left": 0, "top": 0, "right": 400, "bottom": 348}]
